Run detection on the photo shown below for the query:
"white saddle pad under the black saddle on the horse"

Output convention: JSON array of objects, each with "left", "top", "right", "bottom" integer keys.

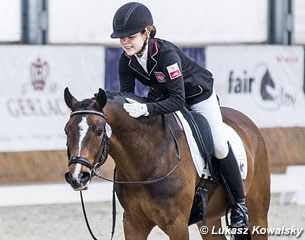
[{"left": 175, "top": 111, "right": 248, "bottom": 179}]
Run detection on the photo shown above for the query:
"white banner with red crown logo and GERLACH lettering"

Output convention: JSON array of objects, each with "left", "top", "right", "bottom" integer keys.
[{"left": 0, "top": 46, "right": 104, "bottom": 152}]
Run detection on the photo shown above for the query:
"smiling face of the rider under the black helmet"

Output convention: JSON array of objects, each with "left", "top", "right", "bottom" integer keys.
[{"left": 120, "top": 32, "right": 146, "bottom": 56}]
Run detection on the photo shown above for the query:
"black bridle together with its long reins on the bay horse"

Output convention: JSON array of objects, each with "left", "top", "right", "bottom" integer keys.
[{"left": 67, "top": 110, "right": 181, "bottom": 240}]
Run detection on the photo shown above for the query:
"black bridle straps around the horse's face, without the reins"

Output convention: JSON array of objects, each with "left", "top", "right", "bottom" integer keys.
[{"left": 67, "top": 110, "right": 111, "bottom": 177}]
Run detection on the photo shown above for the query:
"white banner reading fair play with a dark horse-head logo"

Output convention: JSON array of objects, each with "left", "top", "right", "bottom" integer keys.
[{"left": 206, "top": 46, "right": 305, "bottom": 128}]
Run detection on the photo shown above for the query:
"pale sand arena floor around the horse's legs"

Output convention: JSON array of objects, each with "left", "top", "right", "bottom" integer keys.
[{"left": 0, "top": 201, "right": 305, "bottom": 240}]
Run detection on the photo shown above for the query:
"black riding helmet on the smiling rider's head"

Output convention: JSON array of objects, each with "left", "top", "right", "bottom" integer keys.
[{"left": 110, "top": 2, "right": 153, "bottom": 38}]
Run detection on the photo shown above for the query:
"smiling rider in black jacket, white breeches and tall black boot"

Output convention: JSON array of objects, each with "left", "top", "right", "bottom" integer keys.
[{"left": 111, "top": 2, "right": 248, "bottom": 227}]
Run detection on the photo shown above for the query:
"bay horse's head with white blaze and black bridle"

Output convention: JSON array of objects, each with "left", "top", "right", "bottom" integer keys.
[{"left": 64, "top": 88, "right": 111, "bottom": 190}]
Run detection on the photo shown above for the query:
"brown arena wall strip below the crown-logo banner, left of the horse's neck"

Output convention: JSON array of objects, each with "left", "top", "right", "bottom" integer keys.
[{"left": 0, "top": 150, "right": 114, "bottom": 185}]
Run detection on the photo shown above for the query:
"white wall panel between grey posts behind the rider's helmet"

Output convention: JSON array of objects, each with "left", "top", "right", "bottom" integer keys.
[{"left": 49, "top": 0, "right": 267, "bottom": 45}]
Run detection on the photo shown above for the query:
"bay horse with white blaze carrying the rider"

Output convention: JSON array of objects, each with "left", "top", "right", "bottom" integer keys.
[{"left": 64, "top": 88, "right": 270, "bottom": 240}]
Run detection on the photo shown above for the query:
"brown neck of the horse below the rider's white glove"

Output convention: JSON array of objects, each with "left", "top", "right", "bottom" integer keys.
[{"left": 105, "top": 104, "right": 168, "bottom": 181}]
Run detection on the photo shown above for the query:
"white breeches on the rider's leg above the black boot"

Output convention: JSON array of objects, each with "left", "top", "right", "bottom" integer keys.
[{"left": 190, "top": 89, "right": 229, "bottom": 159}]
